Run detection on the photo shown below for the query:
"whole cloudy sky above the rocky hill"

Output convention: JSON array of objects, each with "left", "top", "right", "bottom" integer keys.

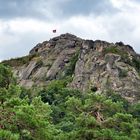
[{"left": 0, "top": 0, "right": 140, "bottom": 60}]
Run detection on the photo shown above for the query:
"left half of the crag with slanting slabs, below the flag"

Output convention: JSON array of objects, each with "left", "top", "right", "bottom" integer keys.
[{"left": 14, "top": 33, "right": 83, "bottom": 87}]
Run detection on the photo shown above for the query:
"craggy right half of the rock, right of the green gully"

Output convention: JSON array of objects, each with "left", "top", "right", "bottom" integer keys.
[{"left": 71, "top": 40, "right": 140, "bottom": 102}]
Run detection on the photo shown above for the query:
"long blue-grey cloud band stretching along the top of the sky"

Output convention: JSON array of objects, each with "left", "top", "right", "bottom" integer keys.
[{"left": 0, "top": 0, "right": 117, "bottom": 20}]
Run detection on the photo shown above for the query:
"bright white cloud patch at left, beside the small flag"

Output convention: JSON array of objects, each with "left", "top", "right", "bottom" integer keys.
[{"left": 0, "top": 18, "right": 56, "bottom": 34}]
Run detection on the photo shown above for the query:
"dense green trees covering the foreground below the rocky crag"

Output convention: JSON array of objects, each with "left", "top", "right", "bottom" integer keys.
[{"left": 0, "top": 65, "right": 140, "bottom": 140}]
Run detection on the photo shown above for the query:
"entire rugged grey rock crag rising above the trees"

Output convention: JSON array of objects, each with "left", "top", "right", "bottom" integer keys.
[{"left": 6, "top": 33, "right": 140, "bottom": 102}]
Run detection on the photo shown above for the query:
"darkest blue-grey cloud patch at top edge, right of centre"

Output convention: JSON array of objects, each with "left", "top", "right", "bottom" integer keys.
[{"left": 60, "top": 0, "right": 118, "bottom": 16}]
